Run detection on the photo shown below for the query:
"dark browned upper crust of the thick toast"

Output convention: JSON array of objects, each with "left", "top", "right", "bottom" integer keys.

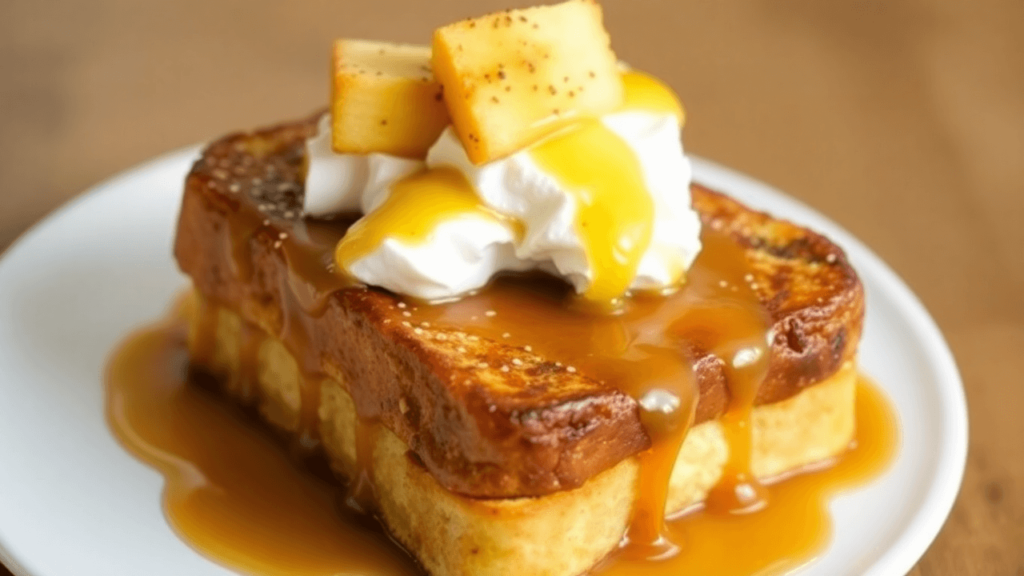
[{"left": 175, "top": 114, "right": 863, "bottom": 497}]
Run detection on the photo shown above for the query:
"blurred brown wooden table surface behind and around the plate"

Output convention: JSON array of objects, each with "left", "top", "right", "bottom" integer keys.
[{"left": 0, "top": 0, "right": 1024, "bottom": 576}]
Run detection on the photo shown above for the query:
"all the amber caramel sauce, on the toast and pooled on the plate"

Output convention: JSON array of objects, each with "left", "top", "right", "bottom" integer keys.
[{"left": 108, "top": 233, "right": 897, "bottom": 576}]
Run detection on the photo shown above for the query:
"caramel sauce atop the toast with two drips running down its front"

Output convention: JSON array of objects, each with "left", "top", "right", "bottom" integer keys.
[{"left": 409, "top": 232, "right": 768, "bottom": 558}]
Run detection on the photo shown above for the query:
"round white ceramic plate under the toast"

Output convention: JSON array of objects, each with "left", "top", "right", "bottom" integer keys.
[{"left": 0, "top": 149, "right": 967, "bottom": 576}]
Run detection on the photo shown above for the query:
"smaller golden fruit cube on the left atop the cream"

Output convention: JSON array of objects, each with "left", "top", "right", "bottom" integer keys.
[{"left": 331, "top": 40, "right": 450, "bottom": 159}]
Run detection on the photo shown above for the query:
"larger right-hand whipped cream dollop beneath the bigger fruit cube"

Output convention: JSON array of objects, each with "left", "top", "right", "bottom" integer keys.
[{"left": 427, "top": 111, "right": 700, "bottom": 293}]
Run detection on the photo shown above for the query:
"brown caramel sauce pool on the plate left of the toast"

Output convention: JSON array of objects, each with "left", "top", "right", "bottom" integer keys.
[{"left": 106, "top": 319, "right": 421, "bottom": 576}]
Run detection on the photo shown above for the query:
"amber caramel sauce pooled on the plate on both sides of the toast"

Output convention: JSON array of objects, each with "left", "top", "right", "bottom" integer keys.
[{"left": 106, "top": 319, "right": 898, "bottom": 576}]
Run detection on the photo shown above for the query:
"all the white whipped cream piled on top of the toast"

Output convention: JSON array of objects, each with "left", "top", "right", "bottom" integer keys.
[{"left": 305, "top": 111, "right": 700, "bottom": 300}]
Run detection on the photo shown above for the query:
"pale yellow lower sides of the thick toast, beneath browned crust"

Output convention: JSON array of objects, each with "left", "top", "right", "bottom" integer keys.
[{"left": 184, "top": 292, "right": 856, "bottom": 576}]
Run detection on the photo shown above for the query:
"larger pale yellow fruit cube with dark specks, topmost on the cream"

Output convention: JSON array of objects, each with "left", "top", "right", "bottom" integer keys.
[{"left": 433, "top": 0, "right": 623, "bottom": 164}]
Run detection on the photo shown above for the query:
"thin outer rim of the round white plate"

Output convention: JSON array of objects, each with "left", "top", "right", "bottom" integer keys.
[{"left": 0, "top": 145, "right": 969, "bottom": 576}]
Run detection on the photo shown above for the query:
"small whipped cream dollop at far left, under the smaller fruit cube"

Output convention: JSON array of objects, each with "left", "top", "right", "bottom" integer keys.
[{"left": 302, "top": 114, "right": 426, "bottom": 216}]
